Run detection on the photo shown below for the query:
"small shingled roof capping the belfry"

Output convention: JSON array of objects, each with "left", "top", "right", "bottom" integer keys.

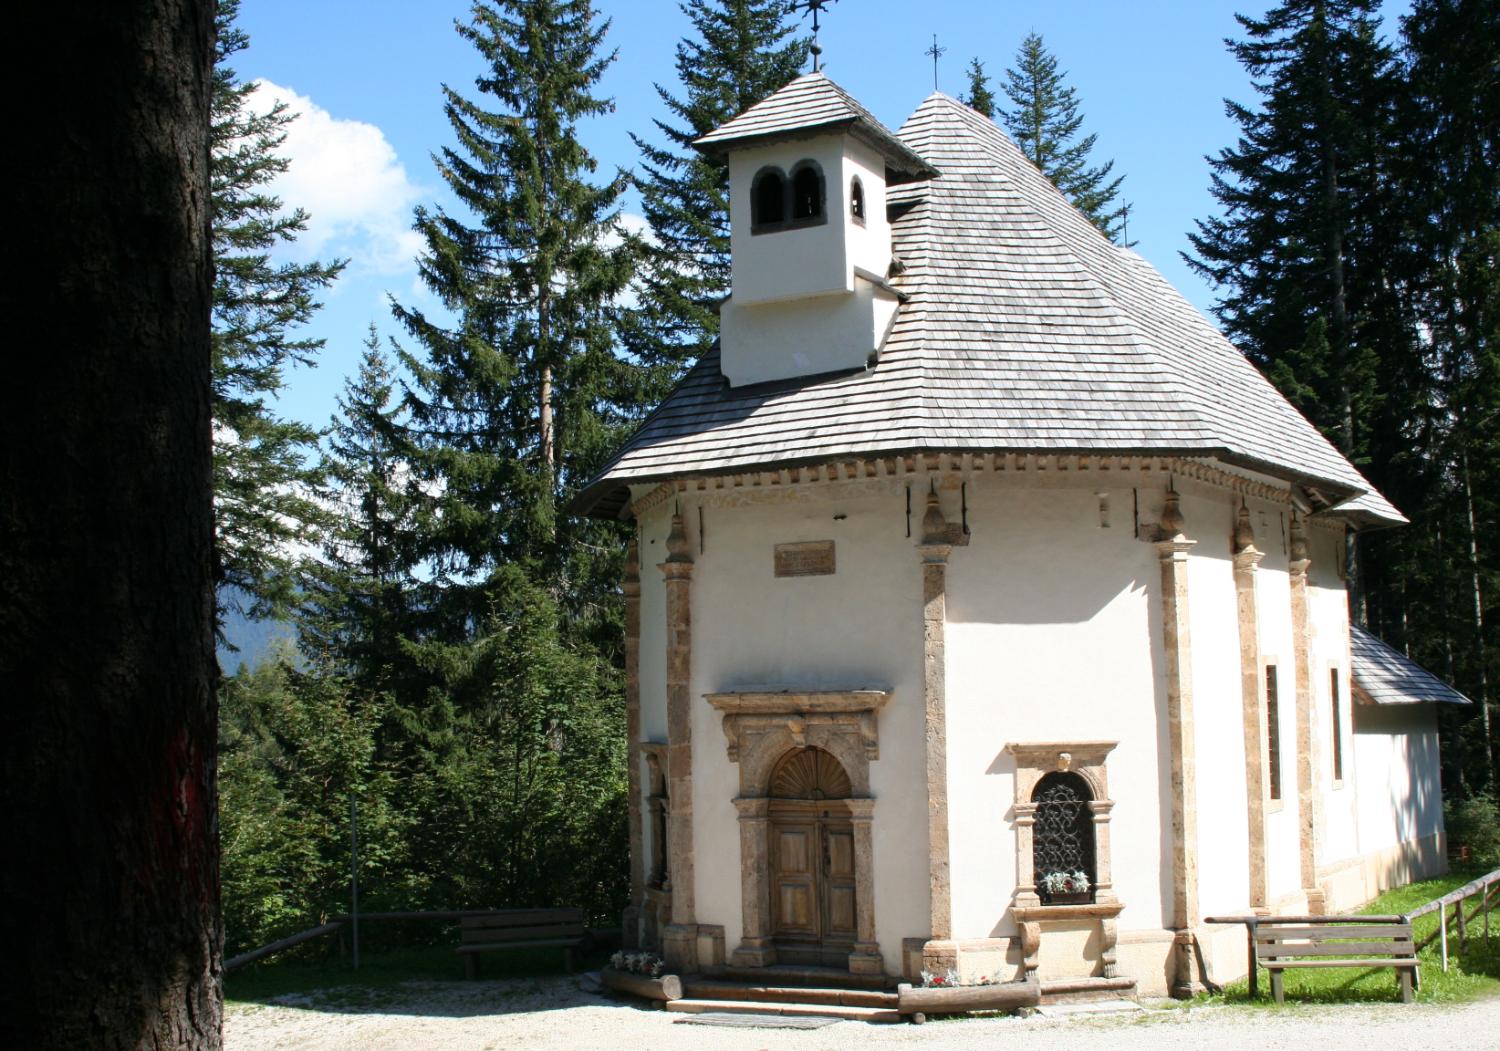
[{"left": 693, "top": 72, "right": 938, "bottom": 183}]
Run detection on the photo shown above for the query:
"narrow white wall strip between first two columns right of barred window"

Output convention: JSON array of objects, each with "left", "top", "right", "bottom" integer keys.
[{"left": 1179, "top": 484, "right": 1250, "bottom": 916}]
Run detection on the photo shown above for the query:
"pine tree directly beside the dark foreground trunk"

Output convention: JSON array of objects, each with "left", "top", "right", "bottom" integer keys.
[{"left": 210, "top": 0, "right": 344, "bottom": 615}]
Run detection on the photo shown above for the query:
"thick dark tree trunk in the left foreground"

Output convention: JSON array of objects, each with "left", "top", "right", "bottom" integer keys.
[{"left": 0, "top": 0, "right": 222, "bottom": 1050}]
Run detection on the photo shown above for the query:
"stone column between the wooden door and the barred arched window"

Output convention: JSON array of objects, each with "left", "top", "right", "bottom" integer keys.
[{"left": 917, "top": 492, "right": 953, "bottom": 958}]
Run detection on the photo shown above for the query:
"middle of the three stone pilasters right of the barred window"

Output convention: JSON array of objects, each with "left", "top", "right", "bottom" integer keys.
[{"left": 1235, "top": 502, "right": 1271, "bottom": 910}]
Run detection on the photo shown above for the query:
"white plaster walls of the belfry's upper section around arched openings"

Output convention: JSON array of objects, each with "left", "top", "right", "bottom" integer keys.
[{"left": 729, "top": 133, "right": 858, "bottom": 306}]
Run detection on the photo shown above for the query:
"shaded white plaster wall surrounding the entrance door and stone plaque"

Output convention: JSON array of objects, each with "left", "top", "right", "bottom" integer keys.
[{"left": 683, "top": 481, "right": 929, "bottom": 973}]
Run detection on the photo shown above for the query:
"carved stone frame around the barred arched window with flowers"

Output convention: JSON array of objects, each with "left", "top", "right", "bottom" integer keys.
[{"left": 1005, "top": 741, "right": 1119, "bottom": 916}]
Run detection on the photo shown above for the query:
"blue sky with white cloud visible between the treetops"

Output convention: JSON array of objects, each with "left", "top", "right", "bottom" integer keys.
[{"left": 236, "top": 0, "right": 1409, "bottom": 426}]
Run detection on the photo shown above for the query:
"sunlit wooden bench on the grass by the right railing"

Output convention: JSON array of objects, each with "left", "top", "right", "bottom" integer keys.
[{"left": 1250, "top": 916, "right": 1418, "bottom": 1003}]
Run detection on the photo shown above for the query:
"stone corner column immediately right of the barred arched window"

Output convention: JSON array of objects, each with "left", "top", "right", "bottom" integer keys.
[{"left": 1157, "top": 489, "right": 1203, "bottom": 997}]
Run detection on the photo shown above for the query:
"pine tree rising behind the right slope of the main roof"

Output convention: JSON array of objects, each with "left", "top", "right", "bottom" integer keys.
[{"left": 1002, "top": 33, "right": 1130, "bottom": 240}]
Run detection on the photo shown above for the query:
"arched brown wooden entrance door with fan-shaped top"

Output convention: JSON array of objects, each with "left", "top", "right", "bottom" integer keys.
[{"left": 770, "top": 748, "right": 855, "bottom": 964}]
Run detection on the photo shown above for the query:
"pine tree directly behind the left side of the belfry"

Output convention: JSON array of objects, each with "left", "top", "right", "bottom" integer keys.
[{"left": 630, "top": 0, "right": 809, "bottom": 368}]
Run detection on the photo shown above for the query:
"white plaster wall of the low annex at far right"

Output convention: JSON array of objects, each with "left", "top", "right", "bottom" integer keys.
[{"left": 1353, "top": 695, "right": 1443, "bottom": 855}]
